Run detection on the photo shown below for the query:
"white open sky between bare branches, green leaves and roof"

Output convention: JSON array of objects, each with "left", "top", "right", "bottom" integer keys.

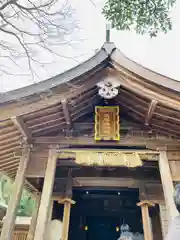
[{"left": 0, "top": 0, "right": 180, "bottom": 93}]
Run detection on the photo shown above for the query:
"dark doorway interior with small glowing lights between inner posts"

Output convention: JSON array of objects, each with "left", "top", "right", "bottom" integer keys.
[{"left": 69, "top": 188, "right": 142, "bottom": 240}]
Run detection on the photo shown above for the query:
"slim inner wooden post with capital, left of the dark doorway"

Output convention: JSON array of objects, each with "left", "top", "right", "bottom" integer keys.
[{"left": 58, "top": 198, "right": 75, "bottom": 240}]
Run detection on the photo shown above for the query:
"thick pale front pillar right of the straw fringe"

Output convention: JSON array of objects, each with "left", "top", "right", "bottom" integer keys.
[{"left": 159, "top": 150, "right": 178, "bottom": 220}]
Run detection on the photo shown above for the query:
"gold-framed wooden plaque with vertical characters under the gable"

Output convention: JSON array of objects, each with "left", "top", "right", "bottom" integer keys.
[{"left": 95, "top": 106, "right": 120, "bottom": 141}]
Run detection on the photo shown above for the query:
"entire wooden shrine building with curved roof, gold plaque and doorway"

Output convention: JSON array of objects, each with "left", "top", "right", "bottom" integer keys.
[{"left": 0, "top": 42, "right": 180, "bottom": 240}]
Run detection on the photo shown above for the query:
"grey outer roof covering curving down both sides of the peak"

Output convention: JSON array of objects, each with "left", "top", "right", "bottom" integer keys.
[{"left": 0, "top": 42, "right": 180, "bottom": 103}]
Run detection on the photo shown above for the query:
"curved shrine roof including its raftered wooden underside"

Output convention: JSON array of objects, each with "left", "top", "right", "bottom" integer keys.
[{"left": 0, "top": 43, "right": 180, "bottom": 189}]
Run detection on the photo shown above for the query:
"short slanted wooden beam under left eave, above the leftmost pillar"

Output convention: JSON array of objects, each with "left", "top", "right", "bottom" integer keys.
[{"left": 11, "top": 116, "right": 31, "bottom": 142}]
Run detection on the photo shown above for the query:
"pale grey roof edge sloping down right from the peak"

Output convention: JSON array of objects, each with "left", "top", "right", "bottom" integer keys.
[{"left": 111, "top": 49, "right": 180, "bottom": 95}]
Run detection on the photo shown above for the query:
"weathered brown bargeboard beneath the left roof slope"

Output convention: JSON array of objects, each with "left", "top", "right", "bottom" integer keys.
[{"left": 0, "top": 66, "right": 106, "bottom": 120}]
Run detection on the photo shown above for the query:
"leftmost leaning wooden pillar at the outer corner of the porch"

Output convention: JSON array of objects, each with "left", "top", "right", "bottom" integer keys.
[{"left": 0, "top": 145, "right": 30, "bottom": 240}]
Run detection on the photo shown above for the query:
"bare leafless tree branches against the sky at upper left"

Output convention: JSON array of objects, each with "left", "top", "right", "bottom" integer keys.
[{"left": 0, "top": 0, "right": 77, "bottom": 77}]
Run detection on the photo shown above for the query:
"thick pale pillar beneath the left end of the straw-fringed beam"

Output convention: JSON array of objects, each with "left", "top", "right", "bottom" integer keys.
[{"left": 34, "top": 149, "right": 57, "bottom": 240}]
